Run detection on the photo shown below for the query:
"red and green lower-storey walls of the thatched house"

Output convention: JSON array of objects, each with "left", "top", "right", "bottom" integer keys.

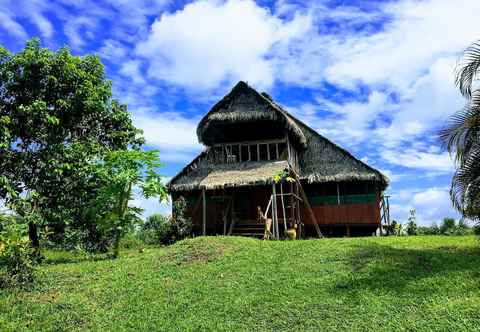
[{"left": 172, "top": 181, "right": 380, "bottom": 237}]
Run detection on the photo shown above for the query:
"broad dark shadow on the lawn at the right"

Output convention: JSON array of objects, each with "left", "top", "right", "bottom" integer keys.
[{"left": 332, "top": 244, "right": 480, "bottom": 296}]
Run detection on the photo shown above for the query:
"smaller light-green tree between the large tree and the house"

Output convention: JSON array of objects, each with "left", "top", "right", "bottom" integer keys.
[{"left": 93, "top": 150, "right": 168, "bottom": 257}]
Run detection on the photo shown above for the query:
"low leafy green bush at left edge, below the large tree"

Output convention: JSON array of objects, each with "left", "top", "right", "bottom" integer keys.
[{"left": 0, "top": 222, "right": 35, "bottom": 288}]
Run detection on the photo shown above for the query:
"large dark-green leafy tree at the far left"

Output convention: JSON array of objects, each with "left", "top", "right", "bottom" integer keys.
[{"left": 0, "top": 39, "right": 143, "bottom": 252}]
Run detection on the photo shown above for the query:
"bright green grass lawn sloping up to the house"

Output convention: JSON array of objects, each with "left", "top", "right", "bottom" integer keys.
[{"left": 0, "top": 236, "right": 480, "bottom": 331}]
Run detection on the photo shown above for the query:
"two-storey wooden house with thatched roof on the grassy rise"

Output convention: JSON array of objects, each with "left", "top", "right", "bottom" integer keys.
[{"left": 168, "top": 82, "right": 388, "bottom": 238}]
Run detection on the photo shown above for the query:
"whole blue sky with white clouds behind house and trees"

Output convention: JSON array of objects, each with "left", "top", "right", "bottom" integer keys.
[{"left": 0, "top": 0, "right": 480, "bottom": 225}]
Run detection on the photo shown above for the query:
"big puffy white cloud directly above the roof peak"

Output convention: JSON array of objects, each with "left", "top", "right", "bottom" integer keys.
[{"left": 137, "top": 0, "right": 311, "bottom": 90}]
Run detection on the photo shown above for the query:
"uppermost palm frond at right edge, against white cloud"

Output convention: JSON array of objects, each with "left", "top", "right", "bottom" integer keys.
[{"left": 456, "top": 41, "right": 480, "bottom": 98}]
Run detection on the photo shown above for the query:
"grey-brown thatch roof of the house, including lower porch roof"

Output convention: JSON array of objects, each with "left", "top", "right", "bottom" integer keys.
[{"left": 169, "top": 82, "right": 388, "bottom": 191}]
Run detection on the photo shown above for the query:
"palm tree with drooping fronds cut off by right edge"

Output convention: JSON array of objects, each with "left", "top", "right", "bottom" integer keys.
[{"left": 440, "top": 42, "right": 480, "bottom": 219}]
